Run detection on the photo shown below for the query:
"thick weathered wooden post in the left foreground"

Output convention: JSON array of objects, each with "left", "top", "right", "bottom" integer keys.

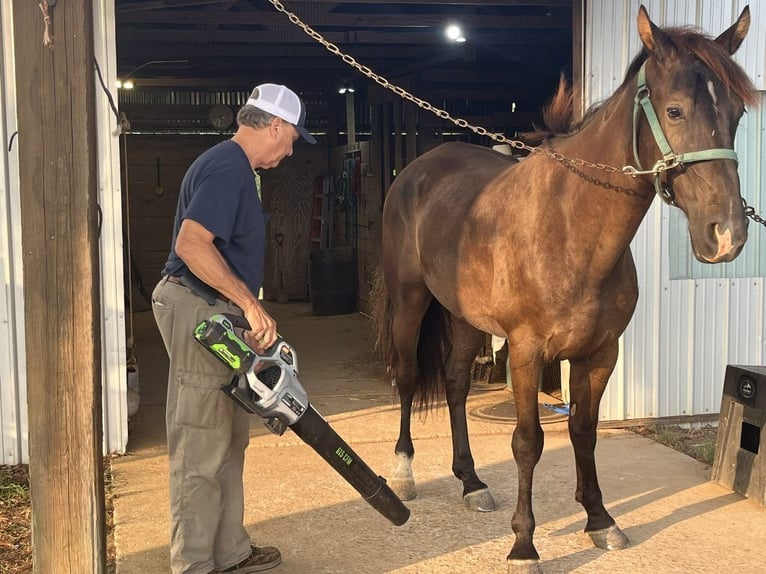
[{"left": 13, "top": 0, "right": 106, "bottom": 574}]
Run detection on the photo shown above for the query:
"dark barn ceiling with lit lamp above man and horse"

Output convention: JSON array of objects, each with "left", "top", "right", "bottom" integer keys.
[{"left": 115, "top": 0, "right": 572, "bottom": 133}]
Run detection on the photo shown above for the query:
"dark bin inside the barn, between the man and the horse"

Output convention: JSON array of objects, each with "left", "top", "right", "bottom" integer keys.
[{"left": 309, "top": 247, "right": 357, "bottom": 315}]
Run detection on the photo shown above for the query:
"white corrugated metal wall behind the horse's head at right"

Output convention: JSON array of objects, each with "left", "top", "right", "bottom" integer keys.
[{"left": 584, "top": 0, "right": 766, "bottom": 420}]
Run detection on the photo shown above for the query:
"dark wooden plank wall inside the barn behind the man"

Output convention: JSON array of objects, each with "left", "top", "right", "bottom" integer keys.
[{"left": 121, "top": 134, "right": 327, "bottom": 309}]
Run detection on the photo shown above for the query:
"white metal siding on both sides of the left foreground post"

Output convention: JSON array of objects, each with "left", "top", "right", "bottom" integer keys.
[{"left": 0, "top": 0, "right": 128, "bottom": 464}]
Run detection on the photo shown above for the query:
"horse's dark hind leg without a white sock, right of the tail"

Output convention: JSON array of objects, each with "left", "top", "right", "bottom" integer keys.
[{"left": 445, "top": 318, "right": 496, "bottom": 512}]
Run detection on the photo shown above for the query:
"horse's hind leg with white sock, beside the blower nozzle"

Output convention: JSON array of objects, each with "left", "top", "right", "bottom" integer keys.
[{"left": 390, "top": 283, "right": 433, "bottom": 500}]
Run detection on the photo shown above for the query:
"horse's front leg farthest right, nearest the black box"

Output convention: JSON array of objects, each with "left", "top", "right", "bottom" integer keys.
[{"left": 569, "top": 342, "right": 630, "bottom": 550}]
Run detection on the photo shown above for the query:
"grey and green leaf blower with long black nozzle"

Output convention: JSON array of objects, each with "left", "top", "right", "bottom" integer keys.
[{"left": 194, "top": 313, "right": 410, "bottom": 526}]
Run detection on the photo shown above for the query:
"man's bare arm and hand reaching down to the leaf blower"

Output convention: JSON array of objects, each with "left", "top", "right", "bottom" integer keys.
[{"left": 175, "top": 219, "right": 277, "bottom": 351}]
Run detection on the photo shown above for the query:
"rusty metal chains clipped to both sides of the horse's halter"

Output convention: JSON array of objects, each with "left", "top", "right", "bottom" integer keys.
[{"left": 269, "top": 0, "right": 766, "bottom": 226}]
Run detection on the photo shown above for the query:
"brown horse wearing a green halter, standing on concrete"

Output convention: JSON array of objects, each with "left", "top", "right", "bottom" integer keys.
[{"left": 373, "top": 6, "right": 757, "bottom": 573}]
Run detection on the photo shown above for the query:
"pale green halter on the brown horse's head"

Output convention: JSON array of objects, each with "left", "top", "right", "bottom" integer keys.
[{"left": 623, "top": 62, "right": 737, "bottom": 205}]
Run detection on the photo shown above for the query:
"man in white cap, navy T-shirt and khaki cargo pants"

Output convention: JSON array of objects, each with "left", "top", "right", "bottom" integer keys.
[{"left": 152, "top": 84, "right": 316, "bottom": 574}]
